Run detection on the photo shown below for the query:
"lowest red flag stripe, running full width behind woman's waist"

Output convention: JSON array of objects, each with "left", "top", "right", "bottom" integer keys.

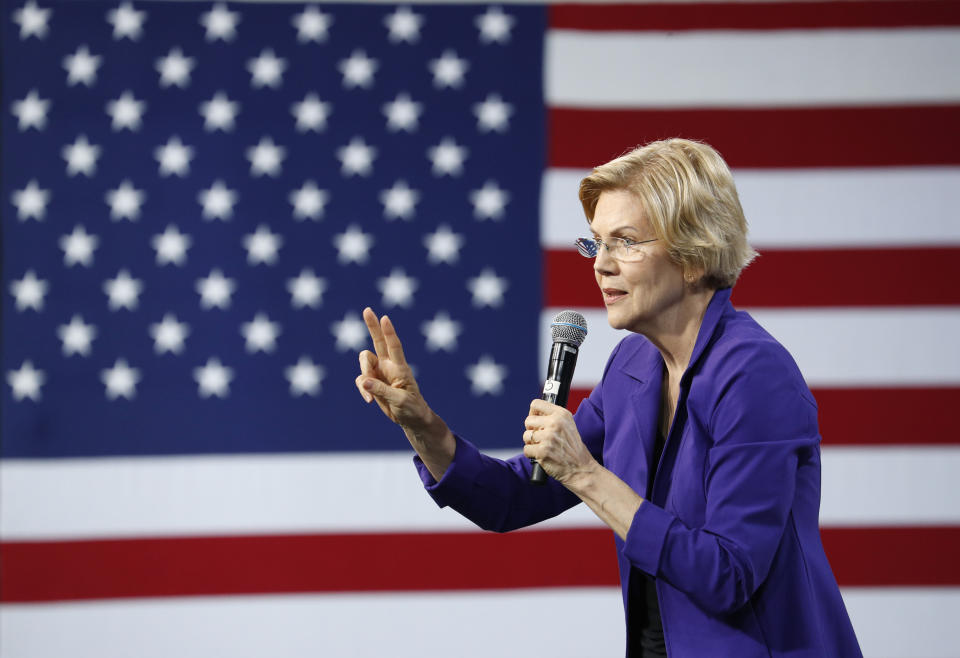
[{"left": 0, "top": 526, "right": 960, "bottom": 603}]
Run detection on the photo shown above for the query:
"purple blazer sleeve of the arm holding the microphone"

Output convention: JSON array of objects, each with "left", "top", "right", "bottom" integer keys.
[{"left": 623, "top": 345, "right": 820, "bottom": 614}]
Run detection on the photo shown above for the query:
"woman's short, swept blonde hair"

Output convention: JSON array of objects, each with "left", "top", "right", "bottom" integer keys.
[{"left": 580, "top": 138, "right": 757, "bottom": 288}]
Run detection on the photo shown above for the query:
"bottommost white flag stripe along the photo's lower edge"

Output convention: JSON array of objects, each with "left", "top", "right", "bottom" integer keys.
[{"left": 0, "top": 587, "right": 960, "bottom": 658}]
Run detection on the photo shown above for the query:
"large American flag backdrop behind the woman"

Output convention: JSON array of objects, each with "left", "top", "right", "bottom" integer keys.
[{"left": 0, "top": 0, "right": 960, "bottom": 658}]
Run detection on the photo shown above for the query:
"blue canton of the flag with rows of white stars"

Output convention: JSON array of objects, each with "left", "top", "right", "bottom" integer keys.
[{"left": 2, "top": 0, "right": 545, "bottom": 457}]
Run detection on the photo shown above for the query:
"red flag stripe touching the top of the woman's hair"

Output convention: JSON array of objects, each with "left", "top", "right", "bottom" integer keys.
[{"left": 549, "top": 105, "right": 960, "bottom": 169}]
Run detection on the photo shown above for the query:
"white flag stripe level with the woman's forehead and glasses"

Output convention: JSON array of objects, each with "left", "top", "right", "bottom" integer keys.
[{"left": 541, "top": 167, "right": 960, "bottom": 249}]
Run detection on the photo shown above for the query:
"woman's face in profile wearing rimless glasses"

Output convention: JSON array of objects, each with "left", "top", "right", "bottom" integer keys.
[{"left": 590, "top": 190, "right": 686, "bottom": 335}]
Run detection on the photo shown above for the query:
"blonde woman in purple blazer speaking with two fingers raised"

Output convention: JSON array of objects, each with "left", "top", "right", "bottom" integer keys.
[{"left": 356, "top": 139, "right": 861, "bottom": 658}]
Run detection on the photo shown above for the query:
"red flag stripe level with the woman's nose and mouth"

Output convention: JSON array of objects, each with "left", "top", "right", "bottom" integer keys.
[{"left": 544, "top": 247, "right": 960, "bottom": 308}]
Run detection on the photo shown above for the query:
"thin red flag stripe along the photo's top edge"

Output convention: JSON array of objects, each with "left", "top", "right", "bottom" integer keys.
[{"left": 549, "top": 0, "right": 960, "bottom": 31}]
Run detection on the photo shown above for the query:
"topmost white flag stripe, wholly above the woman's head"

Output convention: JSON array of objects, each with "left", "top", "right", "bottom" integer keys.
[{"left": 545, "top": 28, "right": 960, "bottom": 108}]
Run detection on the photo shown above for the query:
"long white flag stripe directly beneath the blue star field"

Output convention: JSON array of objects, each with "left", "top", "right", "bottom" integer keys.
[{"left": 0, "top": 446, "right": 960, "bottom": 540}]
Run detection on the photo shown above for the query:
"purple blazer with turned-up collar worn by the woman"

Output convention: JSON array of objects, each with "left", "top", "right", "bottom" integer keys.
[{"left": 416, "top": 289, "right": 862, "bottom": 658}]
